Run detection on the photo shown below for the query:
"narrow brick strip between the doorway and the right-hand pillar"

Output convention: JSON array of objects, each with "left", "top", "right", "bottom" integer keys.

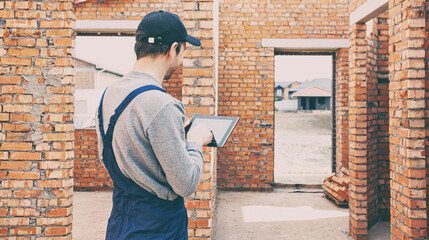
[{"left": 334, "top": 49, "right": 349, "bottom": 173}]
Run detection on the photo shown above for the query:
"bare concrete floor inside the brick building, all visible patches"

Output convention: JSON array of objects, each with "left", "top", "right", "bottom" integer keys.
[{"left": 73, "top": 190, "right": 390, "bottom": 240}]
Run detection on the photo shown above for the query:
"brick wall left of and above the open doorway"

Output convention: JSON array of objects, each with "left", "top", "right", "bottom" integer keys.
[{"left": 218, "top": 0, "right": 349, "bottom": 190}]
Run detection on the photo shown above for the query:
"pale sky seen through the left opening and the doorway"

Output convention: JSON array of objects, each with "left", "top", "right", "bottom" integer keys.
[{"left": 76, "top": 36, "right": 332, "bottom": 82}]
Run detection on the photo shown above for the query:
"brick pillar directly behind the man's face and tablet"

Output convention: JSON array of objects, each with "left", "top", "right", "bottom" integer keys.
[{"left": 182, "top": 0, "right": 217, "bottom": 239}]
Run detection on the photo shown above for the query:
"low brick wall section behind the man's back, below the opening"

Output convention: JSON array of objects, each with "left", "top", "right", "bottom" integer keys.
[{"left": 73, "top": 128, "right": 113, "bottom": 191}]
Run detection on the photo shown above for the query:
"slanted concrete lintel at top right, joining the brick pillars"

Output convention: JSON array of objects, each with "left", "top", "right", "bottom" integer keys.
[{"left": 350, "top": 0, "right": 389, "bottom": 26}]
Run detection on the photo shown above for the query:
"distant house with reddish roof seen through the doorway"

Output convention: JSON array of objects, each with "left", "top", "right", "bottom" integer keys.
[{"left": 289, "top": 78, "right": 332, "bottom": 110}]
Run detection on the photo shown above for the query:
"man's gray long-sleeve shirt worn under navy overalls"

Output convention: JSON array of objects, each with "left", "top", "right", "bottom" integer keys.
[{"left": 96, "top": 72, "right": 203, "bottom": 200}]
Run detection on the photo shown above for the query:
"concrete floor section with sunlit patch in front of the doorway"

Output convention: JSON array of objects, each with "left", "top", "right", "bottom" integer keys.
[{"left": 214, "top": 190, "right": 351, "bottom": 240}]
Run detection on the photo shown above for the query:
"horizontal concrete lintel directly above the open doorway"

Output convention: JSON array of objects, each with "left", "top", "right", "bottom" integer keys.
[{"left": 262, "top": 38, "right": 349, "bottom": 51}]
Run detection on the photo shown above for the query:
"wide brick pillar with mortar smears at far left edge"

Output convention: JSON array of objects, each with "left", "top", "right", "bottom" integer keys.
[{"left": 0, "top": 0, "right": 75, "bottom": 239}]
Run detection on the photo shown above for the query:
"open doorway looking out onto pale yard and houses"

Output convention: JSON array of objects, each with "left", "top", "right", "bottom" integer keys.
[{"left": 274, "top": 52, "right": 335, "bottom": 186}]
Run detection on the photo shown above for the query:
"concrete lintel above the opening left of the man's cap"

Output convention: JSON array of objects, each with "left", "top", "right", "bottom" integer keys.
[{"left": 76, "top": 20, "right": 140, "bottom": 33}]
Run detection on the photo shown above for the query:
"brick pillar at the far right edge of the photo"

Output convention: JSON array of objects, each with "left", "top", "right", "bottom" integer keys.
[{"left": 389, "top": 0, "right": 428, "bottom": 239}]
